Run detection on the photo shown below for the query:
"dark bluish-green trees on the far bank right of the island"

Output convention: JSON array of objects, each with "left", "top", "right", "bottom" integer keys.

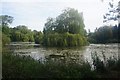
[{"left": 88, "top": 24, "right": 120, "bottom": 43}]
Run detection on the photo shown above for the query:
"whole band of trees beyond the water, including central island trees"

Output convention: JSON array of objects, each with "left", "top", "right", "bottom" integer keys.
[{"left": 0, "top": 8, "right": 120, "bottom": 47}]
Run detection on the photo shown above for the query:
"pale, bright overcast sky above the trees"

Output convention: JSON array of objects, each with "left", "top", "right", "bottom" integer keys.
[{"left": 0, "top": 0, "right": 118, "bottom": 31}]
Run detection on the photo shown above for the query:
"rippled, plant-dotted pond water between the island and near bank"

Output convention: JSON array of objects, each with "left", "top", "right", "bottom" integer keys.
[{"left": 8, "top": 43, "right": 120, "bottom": 62}]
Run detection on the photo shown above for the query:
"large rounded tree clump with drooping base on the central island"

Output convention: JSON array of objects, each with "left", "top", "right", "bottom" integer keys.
[{"left": 43, "top": 8, "right": 87, "bottom": 47}]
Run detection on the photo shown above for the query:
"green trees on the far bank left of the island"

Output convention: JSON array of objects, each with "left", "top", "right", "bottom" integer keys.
[{"left": 0, "top": 15, "right": 43, "bottom": 45}]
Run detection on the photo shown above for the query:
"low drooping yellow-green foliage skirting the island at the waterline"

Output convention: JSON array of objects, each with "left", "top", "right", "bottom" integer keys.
[{"left": 43, "top": 33, "right": 87, "bottom": 47}]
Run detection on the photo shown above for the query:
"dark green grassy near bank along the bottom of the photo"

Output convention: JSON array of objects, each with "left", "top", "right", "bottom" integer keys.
[{"left": 2, "top": 53, "right": 120, "bottom": 79}]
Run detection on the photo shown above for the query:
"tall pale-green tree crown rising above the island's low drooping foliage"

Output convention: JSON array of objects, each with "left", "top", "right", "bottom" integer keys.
[{"left": 43, "top": 8, "right": 85, "bottom": 35}]
